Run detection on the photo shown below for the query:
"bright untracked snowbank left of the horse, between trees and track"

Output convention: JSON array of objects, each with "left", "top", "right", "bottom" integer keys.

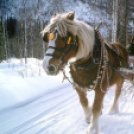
[{"left": 0, "top": 59, "right": 67, "bottom": 110}]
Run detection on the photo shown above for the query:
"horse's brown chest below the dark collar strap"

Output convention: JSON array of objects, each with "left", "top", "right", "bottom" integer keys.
[{"left": 70, "top": 66, "right": 98, "bottom": 88}]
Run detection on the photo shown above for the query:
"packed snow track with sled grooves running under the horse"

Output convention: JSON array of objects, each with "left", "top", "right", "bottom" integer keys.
[{"left": 0, "top": 85, "right": 134, "bottom": 134}]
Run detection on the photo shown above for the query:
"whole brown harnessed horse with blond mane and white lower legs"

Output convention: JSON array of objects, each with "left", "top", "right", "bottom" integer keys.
[{"left": 42, "top": 11, "right": 128, "bottom": 134}]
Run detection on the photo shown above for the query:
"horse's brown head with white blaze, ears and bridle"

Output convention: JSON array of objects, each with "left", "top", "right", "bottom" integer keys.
[{"left": 43, "top": 12, "right": 78, "bottom": 75}]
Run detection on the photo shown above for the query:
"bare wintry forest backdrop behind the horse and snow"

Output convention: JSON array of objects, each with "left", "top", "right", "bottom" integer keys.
[{"left": 0, "top": 0, "right": 134, "bottom": 63}]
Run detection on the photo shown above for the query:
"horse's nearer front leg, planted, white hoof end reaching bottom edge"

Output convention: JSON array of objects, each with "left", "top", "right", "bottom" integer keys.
[{"left": 86, "top": 89, "right": 105, "bottom": 134}]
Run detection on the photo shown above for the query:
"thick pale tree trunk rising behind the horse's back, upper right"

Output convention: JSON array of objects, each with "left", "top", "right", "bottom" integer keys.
[{"left": 112, "top": 0, "right": 119, "bottom": 42}]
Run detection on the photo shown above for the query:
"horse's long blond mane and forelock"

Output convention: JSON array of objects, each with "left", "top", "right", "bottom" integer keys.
[{"left": 42, "top": 13, "right": 94, "bottom": 59}]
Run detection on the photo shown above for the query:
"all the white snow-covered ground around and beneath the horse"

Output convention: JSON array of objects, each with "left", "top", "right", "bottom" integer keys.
[{"left": 0, "top": 59, "right": 134, "bottom": 134}]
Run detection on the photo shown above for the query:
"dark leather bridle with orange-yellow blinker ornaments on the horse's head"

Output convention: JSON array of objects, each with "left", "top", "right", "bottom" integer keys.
[{"left": 45, "top": 30, "right": 78, "bottom": 64}]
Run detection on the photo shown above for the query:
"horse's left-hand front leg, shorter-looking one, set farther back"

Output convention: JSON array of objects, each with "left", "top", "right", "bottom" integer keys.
[{"left": 76, "top": 88, "right": 91, "bottom": 123}]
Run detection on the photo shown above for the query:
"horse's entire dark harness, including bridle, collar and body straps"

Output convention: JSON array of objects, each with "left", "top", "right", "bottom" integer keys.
[{"left": 45, "top": 30, "right": 133, "bottom": 92}]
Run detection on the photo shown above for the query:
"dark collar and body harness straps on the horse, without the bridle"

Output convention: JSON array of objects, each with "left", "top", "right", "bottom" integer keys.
[{"left": 71, "top": 30, "right": 133, "bottom": 93}]
